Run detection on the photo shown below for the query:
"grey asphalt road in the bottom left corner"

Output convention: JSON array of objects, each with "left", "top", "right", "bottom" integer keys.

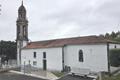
[{"left": 0, "top": 72, "right": 45, "bottom": 80}]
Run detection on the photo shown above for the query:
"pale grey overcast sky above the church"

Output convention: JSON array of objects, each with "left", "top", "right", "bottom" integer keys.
[{"left": 0, "top": 0, "right": 120, "bottom": 41}]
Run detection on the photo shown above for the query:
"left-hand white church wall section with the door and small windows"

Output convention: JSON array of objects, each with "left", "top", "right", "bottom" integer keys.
[{"left": 21, "top": 47, "right": 62, "bottom": 71}]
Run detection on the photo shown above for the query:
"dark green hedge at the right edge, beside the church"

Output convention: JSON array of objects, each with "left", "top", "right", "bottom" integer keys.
[{"left": 110, "top": 49, "right": 120, "bottom": 67}]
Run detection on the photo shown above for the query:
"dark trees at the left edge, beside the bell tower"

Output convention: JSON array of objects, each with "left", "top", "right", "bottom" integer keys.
[{"left": 0, "top": 41, "right": 17, "bottom": 59}]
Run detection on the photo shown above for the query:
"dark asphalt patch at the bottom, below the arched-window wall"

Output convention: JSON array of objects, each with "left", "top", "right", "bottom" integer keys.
[{"left": 58, "top": 75, "right": 93, "bottom": 80}]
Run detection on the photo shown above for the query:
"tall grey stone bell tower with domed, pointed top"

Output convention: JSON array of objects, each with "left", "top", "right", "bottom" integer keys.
[{"left": 16, "top": 1, "right": 28, "bottom": 66}]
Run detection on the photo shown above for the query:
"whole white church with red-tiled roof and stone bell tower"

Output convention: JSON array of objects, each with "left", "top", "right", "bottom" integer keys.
[{"left": 16, "top": 3, "right": 120, "bottom": 72}]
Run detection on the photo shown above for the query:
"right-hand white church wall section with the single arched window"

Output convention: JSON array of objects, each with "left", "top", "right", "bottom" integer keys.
[{"left": 65, "top": 44, "right": 108, "bottom": 72}]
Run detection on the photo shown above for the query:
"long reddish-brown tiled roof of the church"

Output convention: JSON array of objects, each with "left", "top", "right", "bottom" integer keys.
[{"left": 25, "top": 36, "right": 118, "bottom": 48}]
